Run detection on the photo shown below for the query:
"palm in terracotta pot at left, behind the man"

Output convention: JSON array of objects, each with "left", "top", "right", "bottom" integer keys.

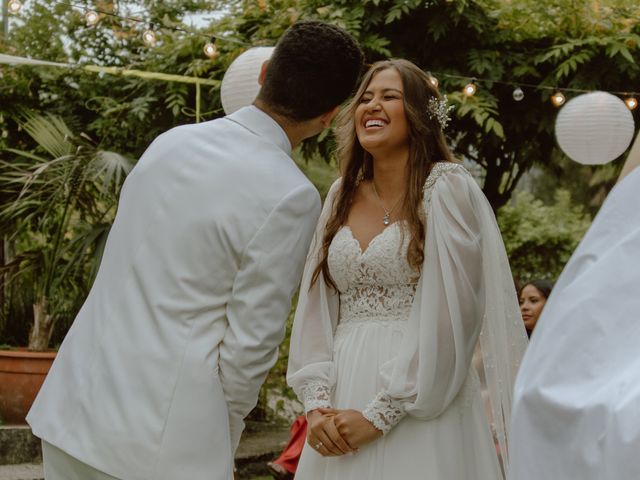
[{"left": 0, "top": 113, "right": 132, "bottom": 423}]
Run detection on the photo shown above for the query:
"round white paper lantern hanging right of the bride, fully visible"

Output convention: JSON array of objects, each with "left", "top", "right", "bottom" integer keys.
[{"left": 556, "top": 92, "right": 635, "bottom": 165}]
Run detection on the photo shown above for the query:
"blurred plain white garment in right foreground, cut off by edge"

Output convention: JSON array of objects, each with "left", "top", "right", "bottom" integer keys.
[{"left": 511, "top": 168, "right": 640, "bottom": 480}]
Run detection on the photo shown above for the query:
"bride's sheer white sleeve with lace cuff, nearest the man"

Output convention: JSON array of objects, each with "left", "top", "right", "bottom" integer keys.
[{"left": 287, "top": 180, "right": 340, "bottom": 413}]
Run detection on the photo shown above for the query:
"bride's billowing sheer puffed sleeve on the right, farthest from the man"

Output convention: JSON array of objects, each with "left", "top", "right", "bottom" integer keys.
[{"left": 363, "top": 163, "right": 526, "bottom": 470}]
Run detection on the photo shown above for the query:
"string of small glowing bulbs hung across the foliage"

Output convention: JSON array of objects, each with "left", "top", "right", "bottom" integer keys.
[{"left": 3, "top": 0, "right": 640, "bottom": 110}]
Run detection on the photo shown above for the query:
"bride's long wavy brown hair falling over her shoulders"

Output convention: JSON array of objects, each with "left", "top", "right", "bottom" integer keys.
[{"left": 311, "top": 59, "right": 454, "bottom": 289}]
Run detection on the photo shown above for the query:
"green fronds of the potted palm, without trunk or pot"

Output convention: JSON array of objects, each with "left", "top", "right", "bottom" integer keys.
[{"left": 0, "top": 114, "right": 132, "bottom": 348}]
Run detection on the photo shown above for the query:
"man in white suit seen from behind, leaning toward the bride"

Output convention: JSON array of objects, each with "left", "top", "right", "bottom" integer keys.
[{"left": 27, "top": 22, "right": 363, "bottom": 480}]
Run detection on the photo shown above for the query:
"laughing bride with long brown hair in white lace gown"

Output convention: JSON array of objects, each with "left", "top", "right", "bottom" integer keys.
[{"left": 287, "top": 60, "right": 526, "bottom": 480}]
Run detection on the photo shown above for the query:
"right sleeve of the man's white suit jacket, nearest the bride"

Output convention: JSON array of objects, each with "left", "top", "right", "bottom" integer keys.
[{"left": 219, "top": 184, "right": 320, "bottom": 452}]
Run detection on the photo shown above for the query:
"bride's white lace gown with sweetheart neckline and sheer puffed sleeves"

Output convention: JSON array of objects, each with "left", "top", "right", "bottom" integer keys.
[{"left": 288, "top": 163, "right": 526, "bottom": 480}]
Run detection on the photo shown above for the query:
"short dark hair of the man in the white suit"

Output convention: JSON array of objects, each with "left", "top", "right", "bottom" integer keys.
[{"left": 258, "top": 21, "right": 364, "bottom": 121}]
